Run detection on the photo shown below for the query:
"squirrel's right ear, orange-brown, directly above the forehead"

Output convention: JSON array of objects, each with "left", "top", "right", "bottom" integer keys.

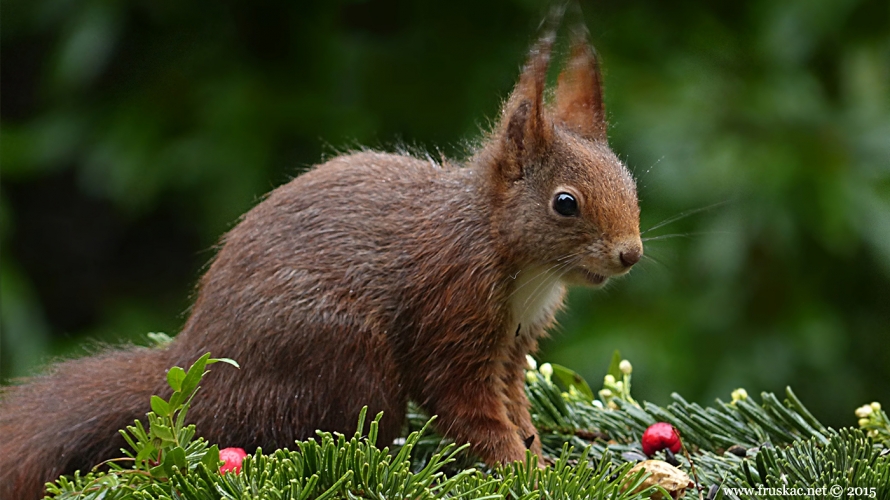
[{"left": 556, "top": 25, "right": 607, "bottom": 141}]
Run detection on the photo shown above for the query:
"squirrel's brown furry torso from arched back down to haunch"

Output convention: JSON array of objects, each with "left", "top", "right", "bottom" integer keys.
[{"left": 177, "top": 152, "right": 503, "bottom": 448}]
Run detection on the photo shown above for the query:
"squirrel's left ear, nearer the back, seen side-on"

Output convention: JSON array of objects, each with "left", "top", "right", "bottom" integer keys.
[{"left": 497, "top": 31, "right": 555, "bottom": 180}]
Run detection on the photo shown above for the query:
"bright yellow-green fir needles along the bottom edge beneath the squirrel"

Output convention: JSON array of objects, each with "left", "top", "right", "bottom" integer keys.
[{"left": 50, "top": 402, "right": 655, "bottom": 500}]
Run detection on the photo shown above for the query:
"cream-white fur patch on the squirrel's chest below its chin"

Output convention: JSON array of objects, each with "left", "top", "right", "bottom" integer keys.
[{"left": 509, "top": 267, "right": 566, "bottom": 333}]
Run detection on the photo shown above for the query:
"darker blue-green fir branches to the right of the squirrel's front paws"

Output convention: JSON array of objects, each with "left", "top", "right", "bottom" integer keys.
[{"left": 527, "top": 366, "right": 890, "bottom": 498}]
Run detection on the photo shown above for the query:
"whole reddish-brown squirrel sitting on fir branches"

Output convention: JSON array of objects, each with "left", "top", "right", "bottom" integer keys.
[{"left": 0, "top": 20, "right": 643, "bottom": 499}]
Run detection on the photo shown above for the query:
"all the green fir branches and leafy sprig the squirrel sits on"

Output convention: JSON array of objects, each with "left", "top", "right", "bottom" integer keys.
[{"left": 49, "top": 354, "right": 890, "bottom": 500}]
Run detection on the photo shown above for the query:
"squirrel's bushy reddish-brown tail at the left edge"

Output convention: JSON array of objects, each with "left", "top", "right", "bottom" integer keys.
[{"left": 0, "top": 348, "right": 169, "bottom": 500}]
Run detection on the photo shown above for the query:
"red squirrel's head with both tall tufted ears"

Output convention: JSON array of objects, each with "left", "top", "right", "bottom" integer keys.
[{"left": 481, "top": 29, "right": 643, "bottom": 286}]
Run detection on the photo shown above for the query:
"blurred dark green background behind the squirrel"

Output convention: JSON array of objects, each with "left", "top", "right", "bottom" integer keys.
[{"left": 0, "top": 0, "right": 890, "bottom": 426}]
